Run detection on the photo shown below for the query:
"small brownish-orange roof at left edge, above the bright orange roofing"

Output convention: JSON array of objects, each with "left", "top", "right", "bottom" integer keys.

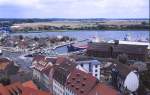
[{"left": 0, "top": 58, "right": 13, "bottom": 70}]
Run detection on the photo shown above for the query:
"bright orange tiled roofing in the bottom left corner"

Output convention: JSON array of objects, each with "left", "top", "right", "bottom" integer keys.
[{"left": 0, "top": 81, "right": 52, "bottom": 95}]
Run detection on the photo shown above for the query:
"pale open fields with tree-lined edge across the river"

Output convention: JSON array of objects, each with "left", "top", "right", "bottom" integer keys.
[{"left": 11, "top": 19, "right": 150, "bottom": 32}]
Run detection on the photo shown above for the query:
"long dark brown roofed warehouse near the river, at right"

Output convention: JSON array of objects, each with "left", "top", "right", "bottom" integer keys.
[{"left": 87, "top": 42, "right": 148, "bottom": 61}]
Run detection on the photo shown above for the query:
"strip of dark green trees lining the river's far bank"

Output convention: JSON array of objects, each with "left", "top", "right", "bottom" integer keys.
[{"left": 12, "top": 24, "right": 150, "bottom": 31}]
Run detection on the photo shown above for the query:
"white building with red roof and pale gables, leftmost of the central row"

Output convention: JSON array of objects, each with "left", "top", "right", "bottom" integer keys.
[{"left": 31, "top": 56, "right": 54, "bottom": 89}]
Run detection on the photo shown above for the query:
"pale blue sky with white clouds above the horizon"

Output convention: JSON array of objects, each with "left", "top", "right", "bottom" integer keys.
[{"left": 0, "top": 0, "right": 149, "bottom": 18}]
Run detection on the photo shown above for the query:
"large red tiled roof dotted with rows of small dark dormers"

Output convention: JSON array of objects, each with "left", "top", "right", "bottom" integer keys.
[{"left": 66, "top": 69, "right": 97, "bottom": 95}]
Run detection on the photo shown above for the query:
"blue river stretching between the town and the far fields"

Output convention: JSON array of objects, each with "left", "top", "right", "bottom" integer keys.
[{"left": 11, "top": 30, "right": 149, "bottom": 40}]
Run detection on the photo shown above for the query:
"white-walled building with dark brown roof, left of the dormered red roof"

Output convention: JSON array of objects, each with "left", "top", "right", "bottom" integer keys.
[{"left": 53, "top": 58, "right": 76, "bottom": 95}]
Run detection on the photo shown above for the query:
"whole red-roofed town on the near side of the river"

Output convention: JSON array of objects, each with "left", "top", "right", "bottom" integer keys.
[{"left": 0, "top": 26, "right": 150, "bottom": 95}]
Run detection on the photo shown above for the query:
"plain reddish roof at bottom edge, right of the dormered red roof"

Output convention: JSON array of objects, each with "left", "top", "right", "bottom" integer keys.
[{"left": 88, "top": 83, "right": 121, "bottom": 95}]
